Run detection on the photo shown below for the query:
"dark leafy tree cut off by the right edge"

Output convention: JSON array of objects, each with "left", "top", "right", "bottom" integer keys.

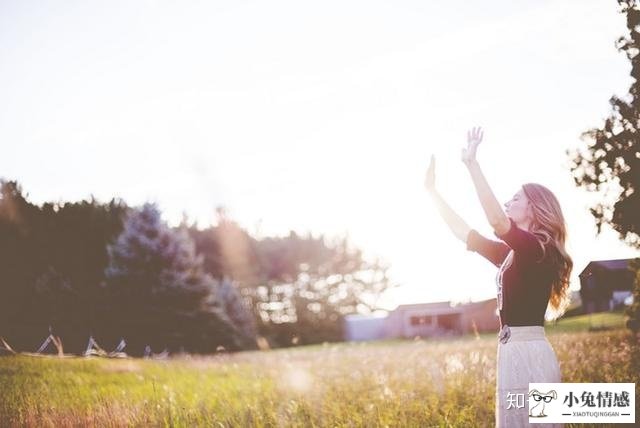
[{"left": 567, "top": 0, "right": 640, "bottom": 248}]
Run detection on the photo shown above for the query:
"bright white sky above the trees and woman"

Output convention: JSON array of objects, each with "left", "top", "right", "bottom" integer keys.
[{"left": 0, "top": 0, "right": 638, "bottom": 308}]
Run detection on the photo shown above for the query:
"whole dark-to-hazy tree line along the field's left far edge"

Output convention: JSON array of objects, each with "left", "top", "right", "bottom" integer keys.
[{"left": 0, "top": 180, "right": 394, "bottom": 356}]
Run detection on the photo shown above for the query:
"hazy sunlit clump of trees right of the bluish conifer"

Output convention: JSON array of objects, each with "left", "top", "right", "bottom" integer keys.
[{"left": 183, "top": 208, "right": 394, "bottom": 346}]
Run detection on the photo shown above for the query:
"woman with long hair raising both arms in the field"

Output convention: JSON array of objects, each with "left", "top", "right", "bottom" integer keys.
[{"left": 425, "top": 128, "right": 573, "bottom": 428}]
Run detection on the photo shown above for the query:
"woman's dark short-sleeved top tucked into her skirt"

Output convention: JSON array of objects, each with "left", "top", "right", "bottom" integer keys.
[{"left": 467, "top": 218, "right": 555, "bottom": 327}]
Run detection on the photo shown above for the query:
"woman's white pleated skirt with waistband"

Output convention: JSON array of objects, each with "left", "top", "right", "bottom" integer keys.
[{"left": 495, "top": 325, "right": 563, "bottom": 428}]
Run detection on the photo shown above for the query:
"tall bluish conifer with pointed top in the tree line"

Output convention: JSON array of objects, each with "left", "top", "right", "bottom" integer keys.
[{"left": 105, "top": 203, "right": 237, "bottom": 353}]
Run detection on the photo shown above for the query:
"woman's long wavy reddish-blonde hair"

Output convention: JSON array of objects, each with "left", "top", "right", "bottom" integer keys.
[{"left": 522, "top": 183, "right": 573, "bottom": 318}]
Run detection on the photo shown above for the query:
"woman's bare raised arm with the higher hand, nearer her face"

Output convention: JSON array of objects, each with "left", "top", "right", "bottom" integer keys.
[{"left": 462, "top": 128, "right": 511, "bottom": 235}]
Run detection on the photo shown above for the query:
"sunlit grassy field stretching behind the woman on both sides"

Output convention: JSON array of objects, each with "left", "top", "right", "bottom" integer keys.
[{"left": 0, "top": 314, "right": 640, "bottom": 427}]
